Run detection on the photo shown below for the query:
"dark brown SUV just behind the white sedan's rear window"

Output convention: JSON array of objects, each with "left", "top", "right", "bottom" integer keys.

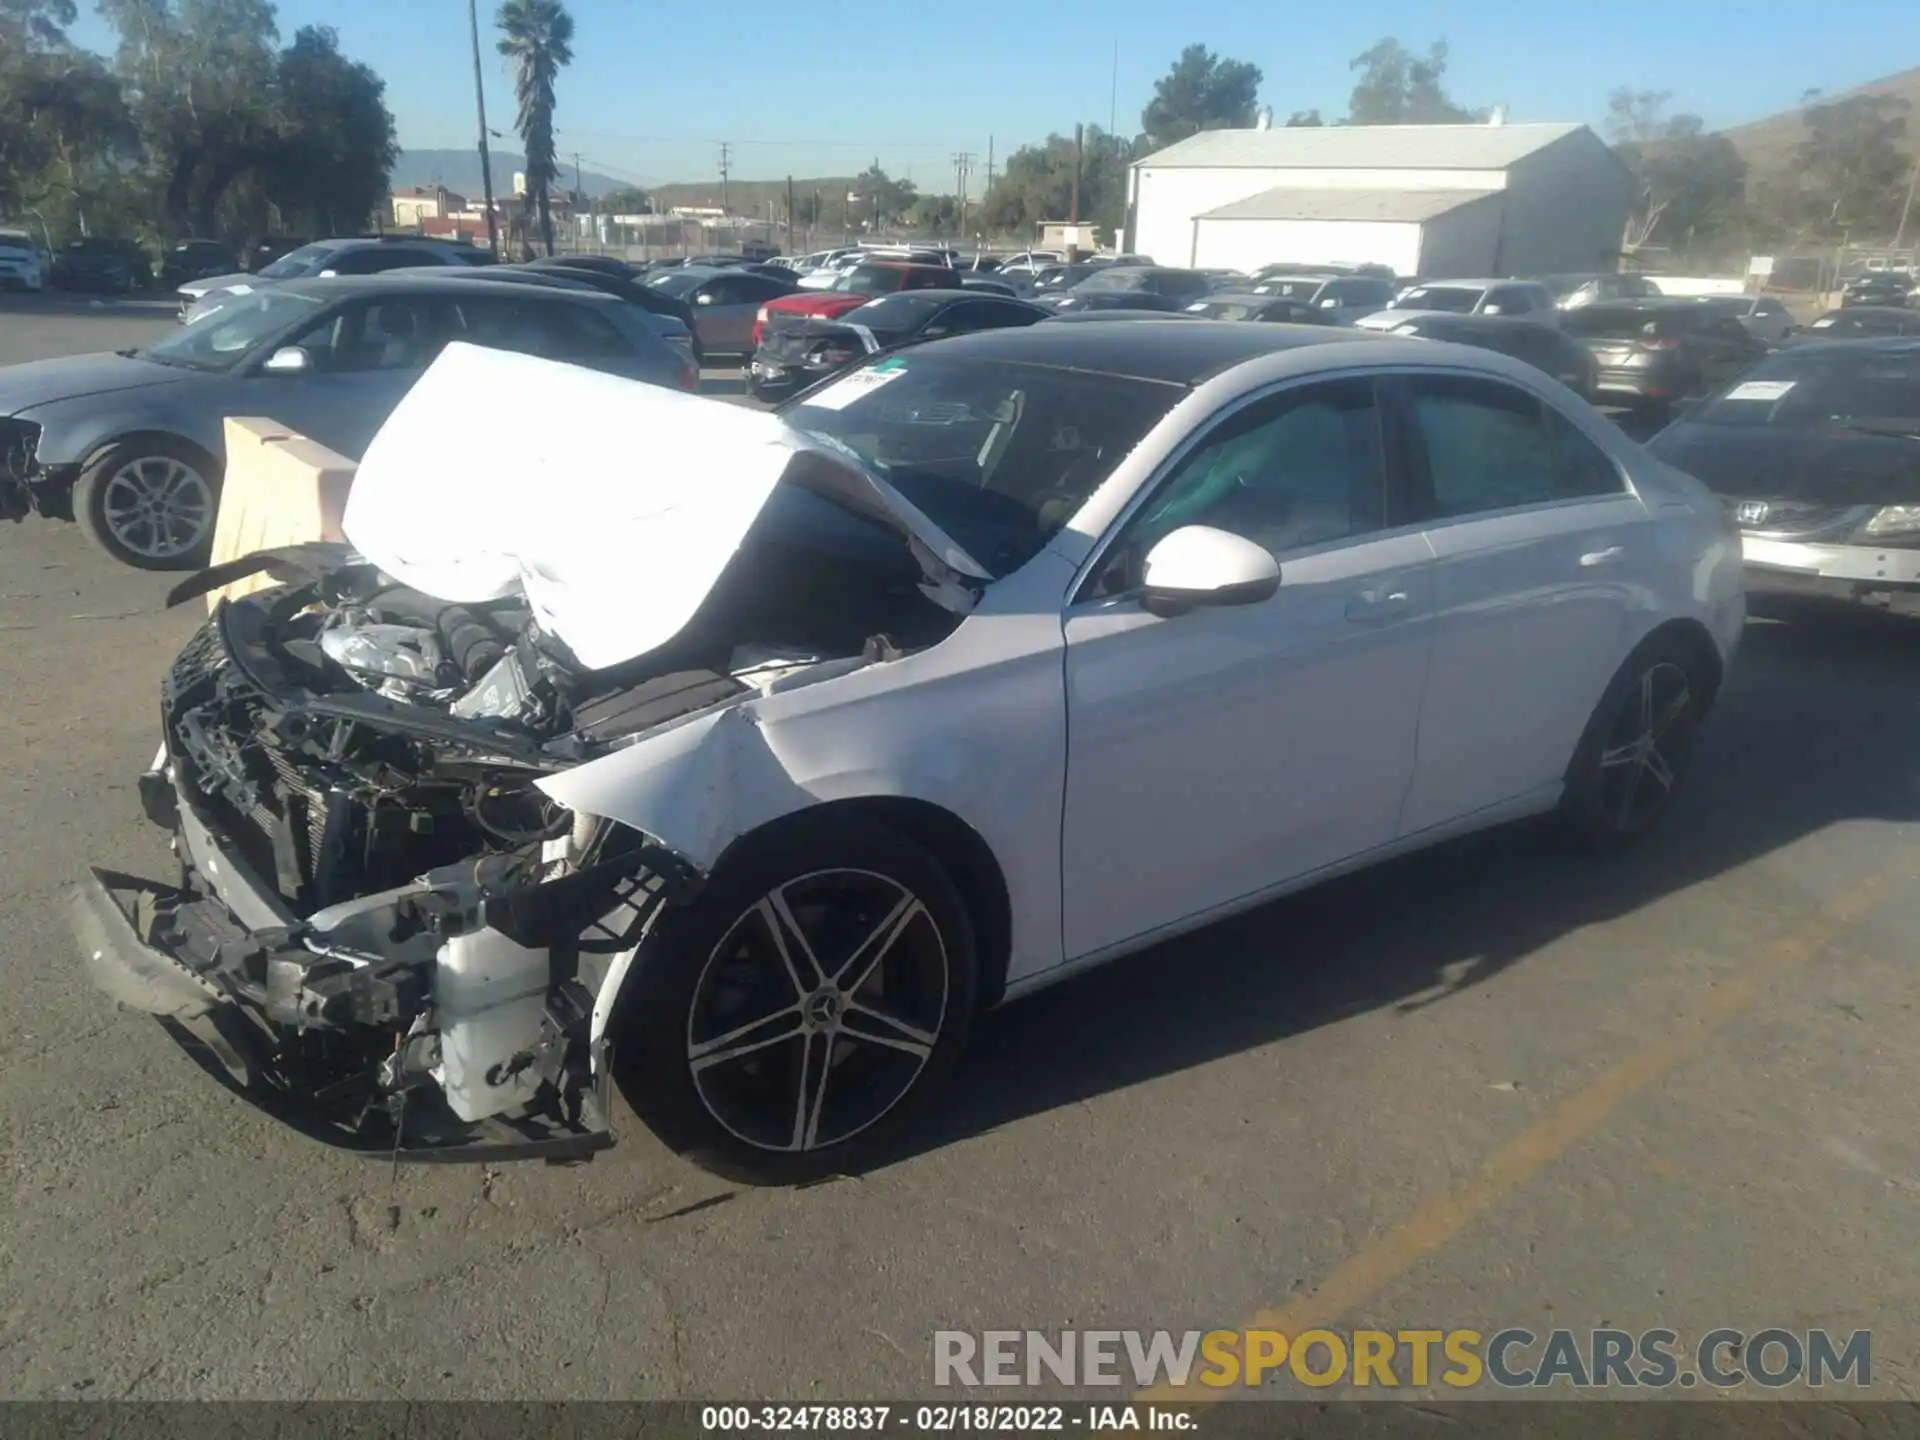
[{"left": 1561, "top": 300, "right": 1766, "bottom": 413}]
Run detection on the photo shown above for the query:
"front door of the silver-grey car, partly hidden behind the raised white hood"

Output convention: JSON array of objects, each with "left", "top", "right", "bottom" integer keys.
[{"left": 236, "top": 296, "right": 453, "bottom": 459}]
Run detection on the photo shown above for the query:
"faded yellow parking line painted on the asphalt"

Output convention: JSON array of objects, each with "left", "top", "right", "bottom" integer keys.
[{"left": 1139, "top": 851, "right": 1920, "bottom": 1404}]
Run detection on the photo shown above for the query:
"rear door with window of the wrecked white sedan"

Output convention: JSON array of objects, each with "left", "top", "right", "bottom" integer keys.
[{"left": 1390, "top": 372, "right": 1659, "bottom": 835}]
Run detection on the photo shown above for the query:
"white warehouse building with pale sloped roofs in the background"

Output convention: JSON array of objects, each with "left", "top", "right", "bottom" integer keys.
[{"left": 1125, "top": 111, "right": 1632, "bottom": 278}]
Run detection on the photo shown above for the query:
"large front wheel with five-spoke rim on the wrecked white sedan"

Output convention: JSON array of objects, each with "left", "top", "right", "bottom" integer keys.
[{"left": 614, "top": 816, "right": 979, "bottom": 1185}]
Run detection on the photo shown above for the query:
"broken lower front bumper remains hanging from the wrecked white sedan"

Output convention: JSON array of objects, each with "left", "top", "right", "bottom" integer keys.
[{"left": 80, "top": 772, "right": 698, "bottom": 1162}]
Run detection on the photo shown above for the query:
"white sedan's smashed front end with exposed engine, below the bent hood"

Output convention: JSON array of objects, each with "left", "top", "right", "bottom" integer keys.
[{"left": 75, "top": 490, "right": 960, "bottom": 1158}]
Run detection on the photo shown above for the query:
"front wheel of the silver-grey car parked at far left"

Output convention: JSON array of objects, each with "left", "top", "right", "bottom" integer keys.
[{"left": 73, "top": 436, "right": 221, "bottom": 570}]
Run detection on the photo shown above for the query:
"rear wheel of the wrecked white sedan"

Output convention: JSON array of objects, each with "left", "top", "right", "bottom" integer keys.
[{"left": 1561, "top": 634, "right": 1707, "bottom": 849}]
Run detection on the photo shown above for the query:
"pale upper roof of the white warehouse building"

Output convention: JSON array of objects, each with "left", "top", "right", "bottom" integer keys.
[{"left": 1133, "top": 123, "right": 1586, "bottom": 171}]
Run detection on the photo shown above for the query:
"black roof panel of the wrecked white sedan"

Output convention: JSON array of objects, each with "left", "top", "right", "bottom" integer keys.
[{"left": 906, "top": 315, "right": 1379, "bottom": 386}]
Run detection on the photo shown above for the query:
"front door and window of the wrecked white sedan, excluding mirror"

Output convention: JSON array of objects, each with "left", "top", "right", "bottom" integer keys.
[{"left": 1062, "top": 378, "right": 1432, "bottom": 958}]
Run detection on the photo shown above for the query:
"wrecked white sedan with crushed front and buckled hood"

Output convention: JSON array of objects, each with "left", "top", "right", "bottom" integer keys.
[{"left": 75, "top": 332, "right": 1745, "bottom": 1181}]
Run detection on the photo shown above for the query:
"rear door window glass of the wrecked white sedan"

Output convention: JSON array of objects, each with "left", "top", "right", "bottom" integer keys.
[{"left": 1407, "top": 376, "right": 1624, "bottom": 520}]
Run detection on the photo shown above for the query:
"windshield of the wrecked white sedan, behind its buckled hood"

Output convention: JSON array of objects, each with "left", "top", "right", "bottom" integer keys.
[{"left": 781, "top": 351, "right": 1187, "bottom": 576}]
